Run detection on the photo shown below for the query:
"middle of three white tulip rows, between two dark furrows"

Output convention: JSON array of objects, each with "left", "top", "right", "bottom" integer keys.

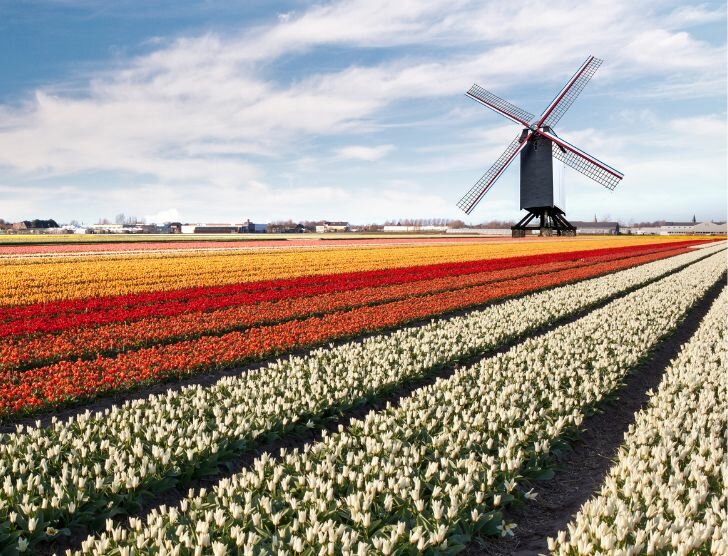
[{"left": 69, "top": 250, "right": 726, "bottom": 554}]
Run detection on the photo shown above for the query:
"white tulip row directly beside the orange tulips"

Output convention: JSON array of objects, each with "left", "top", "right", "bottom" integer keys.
[{"left": 0, "top": 246, "right": 724, "bottom": 547}]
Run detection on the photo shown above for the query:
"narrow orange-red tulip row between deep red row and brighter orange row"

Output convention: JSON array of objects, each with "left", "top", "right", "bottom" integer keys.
[{"left": 0, "top": 250, "right": 676, "bottom": 370}]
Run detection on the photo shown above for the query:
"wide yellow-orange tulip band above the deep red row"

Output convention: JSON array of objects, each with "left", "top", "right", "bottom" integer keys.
[{"left": 0, "top": 233, "right": 712, "bottom": 306}]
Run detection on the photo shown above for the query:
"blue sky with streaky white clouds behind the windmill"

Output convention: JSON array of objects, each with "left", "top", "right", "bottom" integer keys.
[{"left": 0, "top": 0, "right": 727, "bottom": 224}]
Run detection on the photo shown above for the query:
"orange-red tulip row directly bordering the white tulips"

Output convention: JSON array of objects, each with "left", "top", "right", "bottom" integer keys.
[{"left": 0, "top": 248, "right": 674, "bottom": 415}]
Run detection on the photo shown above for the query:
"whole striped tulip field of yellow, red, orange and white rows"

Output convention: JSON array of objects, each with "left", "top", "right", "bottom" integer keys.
[{"left": 0, "top": 236, "right": 728, "bottom": 555}]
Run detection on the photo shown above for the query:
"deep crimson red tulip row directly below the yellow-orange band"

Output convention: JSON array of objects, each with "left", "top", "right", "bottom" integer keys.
[{"left": 0, "top": 242, "right": 694, "bottom": 337}]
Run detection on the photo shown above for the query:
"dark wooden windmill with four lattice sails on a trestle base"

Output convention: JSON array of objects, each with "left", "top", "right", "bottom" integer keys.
[{"left": 458, "top": 52, "right": 624, "bottom": 237}]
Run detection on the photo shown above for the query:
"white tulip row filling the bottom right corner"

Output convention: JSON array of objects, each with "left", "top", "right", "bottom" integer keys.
[{"left": 549, "top": 289, "right": 728, "bottom": 555}]
